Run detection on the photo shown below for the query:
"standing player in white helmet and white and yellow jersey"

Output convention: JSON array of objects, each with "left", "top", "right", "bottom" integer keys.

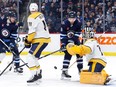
[{"left": 25, "top": 3, "right": 50, "bottom": 83}]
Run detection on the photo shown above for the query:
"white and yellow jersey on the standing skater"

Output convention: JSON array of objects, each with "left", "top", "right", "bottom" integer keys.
[{"left": 27, "top": 12, "right": 50, "bottom": 43}]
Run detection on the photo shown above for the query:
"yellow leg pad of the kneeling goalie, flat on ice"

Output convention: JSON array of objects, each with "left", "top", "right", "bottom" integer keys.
[{"left": 80, "top": 70, "right": 108, "bottom": 85}]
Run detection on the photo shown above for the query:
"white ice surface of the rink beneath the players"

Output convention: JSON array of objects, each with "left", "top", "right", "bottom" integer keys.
[{"left": 0, "top": 55, "right": 116, "bottom": 87}]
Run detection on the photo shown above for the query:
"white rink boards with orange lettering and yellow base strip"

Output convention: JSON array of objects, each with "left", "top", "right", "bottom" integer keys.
[{"left": 6, "top": 34, "right": 116, "bottom": 56}]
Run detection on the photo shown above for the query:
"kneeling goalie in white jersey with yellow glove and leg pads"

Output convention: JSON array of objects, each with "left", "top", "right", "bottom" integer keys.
[{"left": 66, "top": 31, "right": 111, "bottom": 84}]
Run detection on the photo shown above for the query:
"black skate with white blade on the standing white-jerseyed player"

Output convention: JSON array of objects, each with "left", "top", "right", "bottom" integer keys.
[{"left": 27, "top": 70, "right": 42, "bottom": 84}]
